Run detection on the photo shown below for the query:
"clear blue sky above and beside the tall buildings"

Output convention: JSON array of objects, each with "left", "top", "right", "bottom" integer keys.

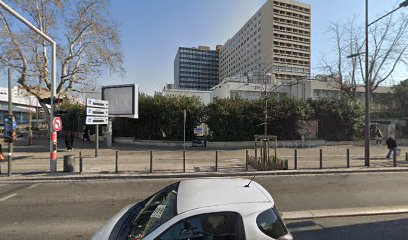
[{"left": 0, "top": 0, "right": 408, "bottom": 94}]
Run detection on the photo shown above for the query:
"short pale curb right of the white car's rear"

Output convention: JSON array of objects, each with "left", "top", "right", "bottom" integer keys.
[{"left": 282, "top": 205, "right": 408, "bottom": 220}]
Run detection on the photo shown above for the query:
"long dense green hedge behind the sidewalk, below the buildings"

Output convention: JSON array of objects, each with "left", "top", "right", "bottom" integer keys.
[{"left": 107, "top": 94, "right": 364, "bottom": 141}]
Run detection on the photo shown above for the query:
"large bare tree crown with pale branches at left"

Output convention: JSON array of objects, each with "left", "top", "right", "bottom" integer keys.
[{"left": 0, "top": 0, "right": 124, "bottom": 118}]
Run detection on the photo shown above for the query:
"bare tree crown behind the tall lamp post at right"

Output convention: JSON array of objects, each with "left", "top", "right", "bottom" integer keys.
[{"left": 322, "top": 8, "right": 408, "bottom": 98}]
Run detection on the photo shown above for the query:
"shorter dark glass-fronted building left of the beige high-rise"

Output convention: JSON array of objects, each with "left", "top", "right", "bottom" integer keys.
[{"left": 174, "top": 46, "right": 219, "bottom": 90}]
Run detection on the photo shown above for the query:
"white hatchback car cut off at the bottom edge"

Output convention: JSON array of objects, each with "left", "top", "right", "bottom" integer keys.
[{"left": 91, "top": 178, "right": 293, "bottom": 240}]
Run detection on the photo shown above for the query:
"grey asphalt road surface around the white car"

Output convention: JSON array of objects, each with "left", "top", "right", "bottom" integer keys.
[{"left": 0, "top": 173, "right": 408, "bottom": 240}]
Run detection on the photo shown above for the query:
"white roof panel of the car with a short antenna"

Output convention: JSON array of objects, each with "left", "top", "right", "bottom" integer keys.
[{"left": 177, "top": 178, "right": 274, "bottom": 214}]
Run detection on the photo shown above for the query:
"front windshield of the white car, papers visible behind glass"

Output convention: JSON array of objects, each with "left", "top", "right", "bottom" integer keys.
[{"left": 127, "top": 183, "right": 179, "bottom": 240}]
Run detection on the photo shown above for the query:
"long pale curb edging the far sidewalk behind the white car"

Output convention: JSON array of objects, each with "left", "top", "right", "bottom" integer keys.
[{"left": 0, "top": 167, "right": 408, "bottom": 182}]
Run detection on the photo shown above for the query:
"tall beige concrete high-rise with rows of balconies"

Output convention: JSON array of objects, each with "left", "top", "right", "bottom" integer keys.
[{"left": 220, "top": 0, "right": 311, "bottom": 81}]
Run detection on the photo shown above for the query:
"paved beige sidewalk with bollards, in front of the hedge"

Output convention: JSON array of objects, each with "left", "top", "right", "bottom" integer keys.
[{"left": 0, "top": 136, "right": 408, "bottom": 177}]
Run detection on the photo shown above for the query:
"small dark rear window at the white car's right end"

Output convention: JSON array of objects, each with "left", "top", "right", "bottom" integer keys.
[{"left": 256, "top": 208, "right": 288, "bottom": 239}]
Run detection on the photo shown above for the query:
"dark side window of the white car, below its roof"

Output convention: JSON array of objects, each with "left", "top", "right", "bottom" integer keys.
[{"left": 156, "top": 212, "right": 245, "bottom": 240}]
